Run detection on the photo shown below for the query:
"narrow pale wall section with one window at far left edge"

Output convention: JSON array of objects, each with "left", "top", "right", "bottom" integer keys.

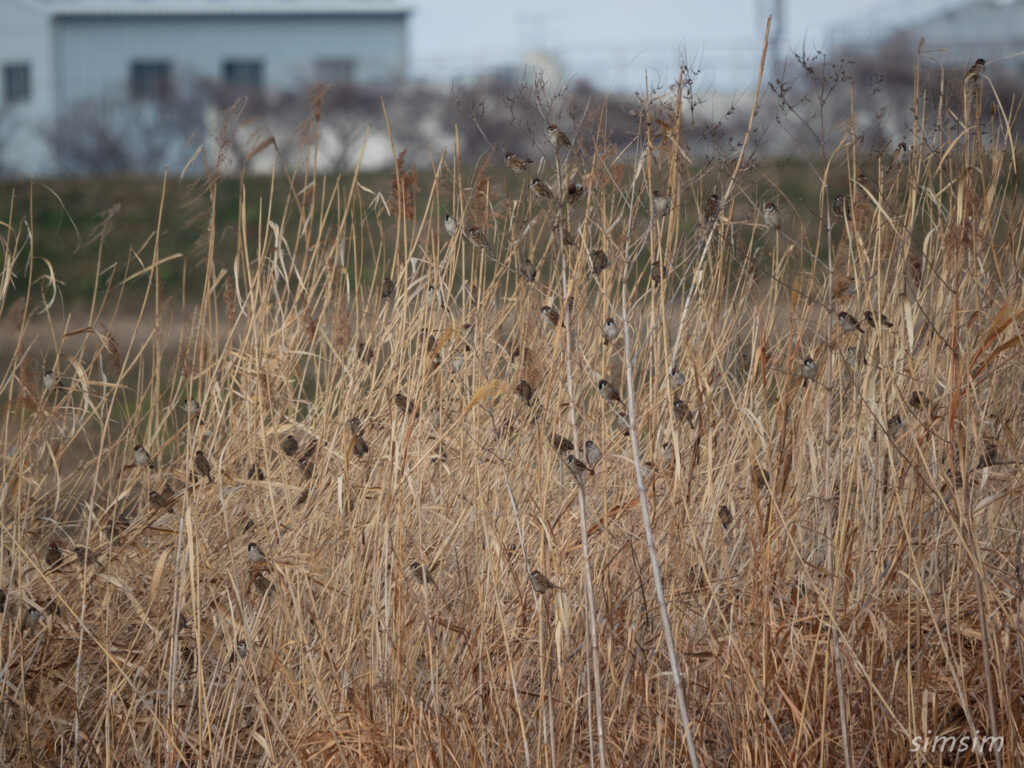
[{"left": 0, "top": 0, "right": 56, "bottom": 175}]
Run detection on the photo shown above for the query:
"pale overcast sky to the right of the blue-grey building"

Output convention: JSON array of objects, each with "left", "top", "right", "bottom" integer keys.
[{"left": 410, "top": 0, "right": 966, "bottom": 90}]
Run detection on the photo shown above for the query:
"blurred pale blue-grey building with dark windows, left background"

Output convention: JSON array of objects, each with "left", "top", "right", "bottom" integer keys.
[{"left": 0, "top": 0, "right": 410, "bottom": 176}]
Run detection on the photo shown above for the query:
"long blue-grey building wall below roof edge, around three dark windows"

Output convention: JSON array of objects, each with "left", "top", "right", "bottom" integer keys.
[{"left": 54, "top": 14, "right": 406, "bottom": 109}]
